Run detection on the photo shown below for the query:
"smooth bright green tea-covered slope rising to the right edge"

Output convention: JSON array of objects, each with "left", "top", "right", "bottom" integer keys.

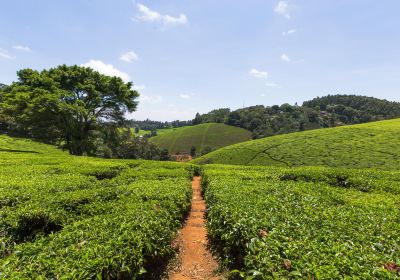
[{"left": 193, "top": 119, "right": 400, "bottom": 169}]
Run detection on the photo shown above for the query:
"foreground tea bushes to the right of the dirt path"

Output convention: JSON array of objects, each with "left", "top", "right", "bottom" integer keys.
[{"left": 203, "top": 165, "right": 400, "bottom": 279}]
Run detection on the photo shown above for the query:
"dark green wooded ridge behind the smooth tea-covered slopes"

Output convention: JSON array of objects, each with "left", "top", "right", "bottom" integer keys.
[{"left": 192, "top": 95, "right": 400, "bottom": 138}]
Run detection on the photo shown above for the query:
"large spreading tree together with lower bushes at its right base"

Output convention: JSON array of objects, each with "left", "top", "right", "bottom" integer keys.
[{"left": 0, "top": 65, "right": 170, "bottom": 159}]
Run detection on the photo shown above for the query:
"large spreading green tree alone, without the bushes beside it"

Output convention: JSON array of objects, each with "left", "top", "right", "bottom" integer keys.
[{"left": 0, "top": 65, "right": 139, "bottom": 155}]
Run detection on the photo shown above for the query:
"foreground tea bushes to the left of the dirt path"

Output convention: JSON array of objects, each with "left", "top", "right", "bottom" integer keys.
[{"left": 0, "top": 136, "right": 192, "bottom": 279}]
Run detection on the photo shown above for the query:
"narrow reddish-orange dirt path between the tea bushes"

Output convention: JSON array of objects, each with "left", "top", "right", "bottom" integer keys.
[{"left": 169, "top": 177, "right": 221, "bottom": 280}]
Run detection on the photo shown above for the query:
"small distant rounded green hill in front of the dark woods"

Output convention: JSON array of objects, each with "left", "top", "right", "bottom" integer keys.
[{"left": 150, "top": 123, "right": 251, "bottom": 154}]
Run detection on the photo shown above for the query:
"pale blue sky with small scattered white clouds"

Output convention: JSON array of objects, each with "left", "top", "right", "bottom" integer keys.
[{"left": 0, "top": 0, "right": 400, "bottom": 121}]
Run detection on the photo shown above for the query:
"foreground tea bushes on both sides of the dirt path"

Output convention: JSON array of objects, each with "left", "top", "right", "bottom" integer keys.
[{"left": 0, "top": 134, "right": 400, "bottom": 279}]
